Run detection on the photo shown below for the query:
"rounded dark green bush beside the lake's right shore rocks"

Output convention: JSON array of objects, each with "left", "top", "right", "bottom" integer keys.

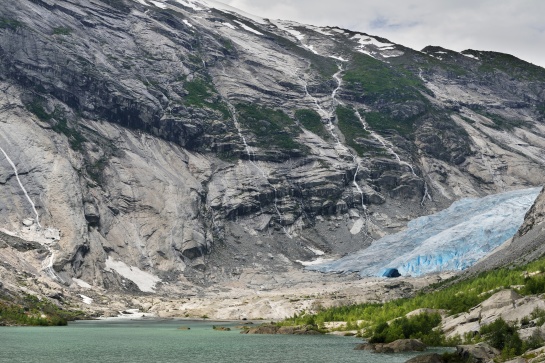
[{"left": 369, "top": 313, "right": 445, "bottom": 346}]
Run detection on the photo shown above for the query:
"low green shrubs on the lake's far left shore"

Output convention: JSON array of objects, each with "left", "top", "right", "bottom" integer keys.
[{"left": 0, "top": 295, "right": 84, "bottom": 326}]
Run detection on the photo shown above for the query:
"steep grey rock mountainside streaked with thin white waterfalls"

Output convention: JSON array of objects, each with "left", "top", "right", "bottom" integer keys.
[{"left": 0, "top": 0, "right": 545, "bottom": 308}]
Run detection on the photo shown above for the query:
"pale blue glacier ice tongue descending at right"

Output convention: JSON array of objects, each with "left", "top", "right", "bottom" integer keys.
[{"left": 307, "top": 188, "right": 541, "bottom": 276}]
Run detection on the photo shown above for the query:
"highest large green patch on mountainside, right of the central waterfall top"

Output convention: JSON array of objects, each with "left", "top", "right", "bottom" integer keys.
[{"left": 343, "top": 54, "right": 427, "bottom": 103}]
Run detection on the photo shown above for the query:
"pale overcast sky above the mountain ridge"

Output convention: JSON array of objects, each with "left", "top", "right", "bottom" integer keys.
[{"left": 220, "top": 0, "right": 545, "bottom": 67}]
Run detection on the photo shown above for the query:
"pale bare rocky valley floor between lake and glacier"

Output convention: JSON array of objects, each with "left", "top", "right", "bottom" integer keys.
[{"left": 73, "top": 270, "right": 452, "bottom": 320}]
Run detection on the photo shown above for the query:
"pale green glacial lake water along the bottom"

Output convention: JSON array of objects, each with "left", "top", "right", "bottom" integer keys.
[{"left": 0, "top": 320, "right": 446, "bottom": 363}]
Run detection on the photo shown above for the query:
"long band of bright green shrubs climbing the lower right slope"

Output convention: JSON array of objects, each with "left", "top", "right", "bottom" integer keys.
[{"left": 281, "top": 257, "right": 545, "bottom": 349}]
